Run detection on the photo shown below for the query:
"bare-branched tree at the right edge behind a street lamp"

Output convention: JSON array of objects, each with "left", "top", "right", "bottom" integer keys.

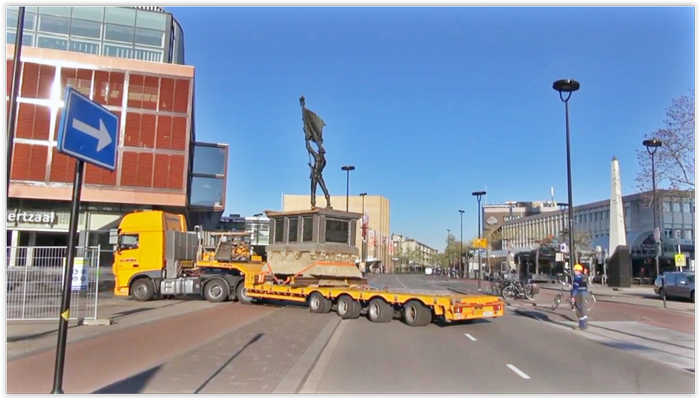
[{"left": 637, "top": 89, "right": 695, "bottom": 194}]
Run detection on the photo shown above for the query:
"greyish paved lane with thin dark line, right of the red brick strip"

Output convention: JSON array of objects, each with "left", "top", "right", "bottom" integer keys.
[{"left": 100, "top": 306, "right": 337, "bottom": 393}]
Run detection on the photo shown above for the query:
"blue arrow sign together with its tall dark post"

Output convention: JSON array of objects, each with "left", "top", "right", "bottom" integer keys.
[{"left": 51, "top": 86, "right": 119, "bottom": 394}]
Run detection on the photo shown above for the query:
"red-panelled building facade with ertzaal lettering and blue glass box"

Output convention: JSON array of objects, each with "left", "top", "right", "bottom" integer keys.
[{"left": 6, "top": 44, "right": 228, "bottom": 262}]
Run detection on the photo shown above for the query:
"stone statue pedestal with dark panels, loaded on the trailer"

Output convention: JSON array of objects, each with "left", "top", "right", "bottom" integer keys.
[{"left": 265, "top": 208, "right": 363, "bottom": 285}]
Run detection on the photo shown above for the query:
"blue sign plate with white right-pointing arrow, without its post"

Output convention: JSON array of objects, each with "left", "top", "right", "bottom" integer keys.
[{"left": 58, "top": 86, "right": 119, "bottom": 171}]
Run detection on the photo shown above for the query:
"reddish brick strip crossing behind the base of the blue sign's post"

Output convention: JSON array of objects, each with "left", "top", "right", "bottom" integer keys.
[{"left": 7, "top": 303, "right": 278, "bottom": 393}]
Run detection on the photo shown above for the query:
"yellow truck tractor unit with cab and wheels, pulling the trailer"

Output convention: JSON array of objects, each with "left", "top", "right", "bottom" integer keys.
[{"left": 112, "top": 211, "right": 258, "bottom": 302}]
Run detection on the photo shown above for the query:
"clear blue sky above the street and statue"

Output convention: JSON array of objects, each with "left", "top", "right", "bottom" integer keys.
[{"left": 170, "top": 7, "right": 695, "bottom": 248}]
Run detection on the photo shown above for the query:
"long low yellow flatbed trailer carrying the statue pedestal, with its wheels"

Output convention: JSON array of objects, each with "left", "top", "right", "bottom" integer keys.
[{"left": 239, "top": 265, "right": 505, "bottom": 326}]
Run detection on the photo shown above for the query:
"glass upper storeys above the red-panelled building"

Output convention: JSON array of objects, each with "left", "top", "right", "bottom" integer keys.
[{"left": 5, "top": 6, "right": 172, "bottom": 62}]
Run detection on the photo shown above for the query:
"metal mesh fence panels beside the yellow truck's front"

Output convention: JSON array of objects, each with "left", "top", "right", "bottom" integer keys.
[{"left": 5, "top": 246, "right": 100, "bottom": 320}]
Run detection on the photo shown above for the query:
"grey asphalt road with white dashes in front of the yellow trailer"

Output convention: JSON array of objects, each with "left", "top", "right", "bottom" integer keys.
[{"left": 302, "top": 275, "right": 695, "bottom": 393}]
